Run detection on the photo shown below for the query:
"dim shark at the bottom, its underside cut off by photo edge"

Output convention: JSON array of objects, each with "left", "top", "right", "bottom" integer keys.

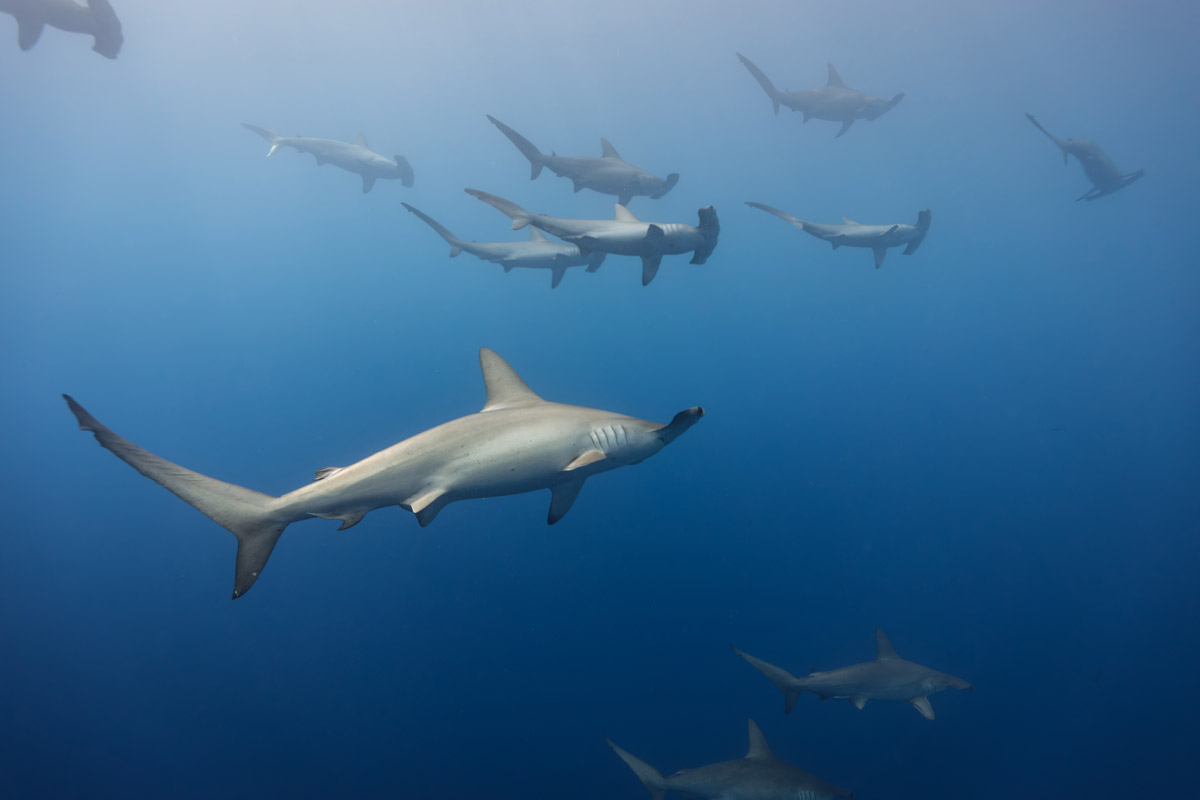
[{"left": 605, "top": 720, "right": 854, "bottom": 800}]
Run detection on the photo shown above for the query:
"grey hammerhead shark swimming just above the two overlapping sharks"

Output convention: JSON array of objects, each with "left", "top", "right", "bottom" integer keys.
[{"left": 487, "top": 114, "right": 679, "bottom": 205}]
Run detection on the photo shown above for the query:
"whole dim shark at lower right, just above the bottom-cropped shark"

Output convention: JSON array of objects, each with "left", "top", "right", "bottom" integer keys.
[{"left": 733, "top": 628, "right": 972, "bottom": 720}]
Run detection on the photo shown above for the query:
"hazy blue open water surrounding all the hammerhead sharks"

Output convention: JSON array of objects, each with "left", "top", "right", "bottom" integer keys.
[{"left": 0, "top": 0, "right": 1200, "bottom": 800}]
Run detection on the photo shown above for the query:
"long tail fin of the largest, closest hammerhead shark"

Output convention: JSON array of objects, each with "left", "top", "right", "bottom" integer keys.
[{"left": 62, "top": 395, "right": 292, "bottom": 599}]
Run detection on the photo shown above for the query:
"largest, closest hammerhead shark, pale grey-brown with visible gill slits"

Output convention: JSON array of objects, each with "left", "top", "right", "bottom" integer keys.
[{"left": 62, "top": 348, "right": 704, "bottom": 599}]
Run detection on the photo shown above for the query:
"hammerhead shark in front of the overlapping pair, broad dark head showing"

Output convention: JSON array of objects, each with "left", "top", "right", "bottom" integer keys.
[{"left": 464, "top": 188, "right": 721, "bottom": 287}]
